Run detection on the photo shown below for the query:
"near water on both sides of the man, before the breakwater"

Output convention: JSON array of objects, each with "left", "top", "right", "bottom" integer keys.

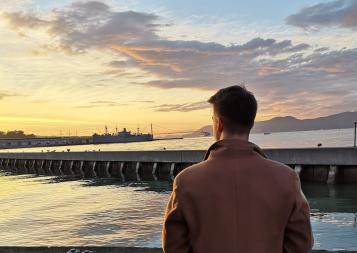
[{"left": 0, "top": 173, "right": 357, "bottom": 250}]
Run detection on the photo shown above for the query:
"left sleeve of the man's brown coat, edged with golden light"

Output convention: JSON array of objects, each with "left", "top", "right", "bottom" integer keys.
[{"left": 162, "top": 179, "right": 192, "bottom": 253}]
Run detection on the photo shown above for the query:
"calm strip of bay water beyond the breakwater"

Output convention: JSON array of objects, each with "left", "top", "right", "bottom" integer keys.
[{"left": 0, "top": 129, "right": 354, "bottom": 152}]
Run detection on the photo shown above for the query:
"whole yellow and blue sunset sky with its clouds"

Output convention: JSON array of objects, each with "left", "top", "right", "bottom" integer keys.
[{"left": 0, "top": 0, "right": 357, "bottom": 135}]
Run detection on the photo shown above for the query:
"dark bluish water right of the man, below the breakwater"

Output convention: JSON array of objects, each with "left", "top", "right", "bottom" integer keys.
[{"left": 303, "top": 184, "right": 357, "bottom": 250}]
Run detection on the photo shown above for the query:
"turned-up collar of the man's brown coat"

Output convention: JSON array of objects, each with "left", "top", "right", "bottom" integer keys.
[{"left": 203, "top": 139, "right": 266, "bottom": 161}]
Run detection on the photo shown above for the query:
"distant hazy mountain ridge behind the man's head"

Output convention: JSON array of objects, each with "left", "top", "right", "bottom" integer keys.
[{"left": 183, "top": 112, "right": 357, "bottom": 138}]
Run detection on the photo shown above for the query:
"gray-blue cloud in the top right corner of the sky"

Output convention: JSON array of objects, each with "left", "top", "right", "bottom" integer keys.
[{"left": 286, "top": 0, "right": 357, "bottom": 30}]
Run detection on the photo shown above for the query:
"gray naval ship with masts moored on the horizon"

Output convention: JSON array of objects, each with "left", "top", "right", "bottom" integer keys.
[{"left": 93, "top": 126, "right": 154, "bottom": 144}]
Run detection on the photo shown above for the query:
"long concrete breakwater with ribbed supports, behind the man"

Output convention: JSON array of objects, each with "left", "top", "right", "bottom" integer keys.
[{"left": 0, "top": 147, "right": 357, "bottom": 184}]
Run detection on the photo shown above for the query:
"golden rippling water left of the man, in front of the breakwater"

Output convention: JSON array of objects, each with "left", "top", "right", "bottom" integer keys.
[{"left": 0, "top": 176, "right": 168, "bottom": 246}]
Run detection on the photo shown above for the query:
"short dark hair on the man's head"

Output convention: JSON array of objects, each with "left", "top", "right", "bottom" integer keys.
[{"left": 208, "top": 85, "right": 258, "bottom": 134}]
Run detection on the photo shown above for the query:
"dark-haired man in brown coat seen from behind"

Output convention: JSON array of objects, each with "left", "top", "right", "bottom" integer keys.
[{"left": 162, "top": 86, "right": 313, "bottom": 253}]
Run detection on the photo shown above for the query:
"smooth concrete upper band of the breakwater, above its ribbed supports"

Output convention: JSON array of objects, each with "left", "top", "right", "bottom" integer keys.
[{"left": 0, "top": 147, "right": 357, "bottom": 165}]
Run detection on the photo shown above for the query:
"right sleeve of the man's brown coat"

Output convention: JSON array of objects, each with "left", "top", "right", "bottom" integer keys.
[{"left": 283, "top": 174, "right": 314, "bottom": 253}]
